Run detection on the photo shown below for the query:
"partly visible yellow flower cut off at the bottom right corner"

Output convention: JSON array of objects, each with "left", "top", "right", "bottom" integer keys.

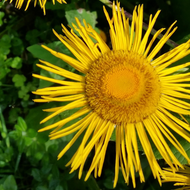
[{"left": 163, "top": 166, "right": 190, "bottom": 190}]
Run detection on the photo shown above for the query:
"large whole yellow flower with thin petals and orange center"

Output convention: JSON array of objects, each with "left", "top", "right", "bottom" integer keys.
[{"left": 33, "top": 0, "right": 190, "bottom": 187}]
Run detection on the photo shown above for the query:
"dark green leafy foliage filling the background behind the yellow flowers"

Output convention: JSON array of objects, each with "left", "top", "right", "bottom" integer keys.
[{"left": 0, "top": 0, "right": 190, "bottom": 190}]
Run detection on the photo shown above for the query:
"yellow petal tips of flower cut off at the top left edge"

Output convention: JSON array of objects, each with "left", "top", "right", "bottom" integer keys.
[{"left": 6, "top": 0, "right": 66, "bottom": 14}]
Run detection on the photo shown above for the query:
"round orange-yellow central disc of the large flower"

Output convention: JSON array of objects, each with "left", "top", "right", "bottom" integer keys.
[{"left": 86, "top": 50, "right": 161, "bottom": 124}]
